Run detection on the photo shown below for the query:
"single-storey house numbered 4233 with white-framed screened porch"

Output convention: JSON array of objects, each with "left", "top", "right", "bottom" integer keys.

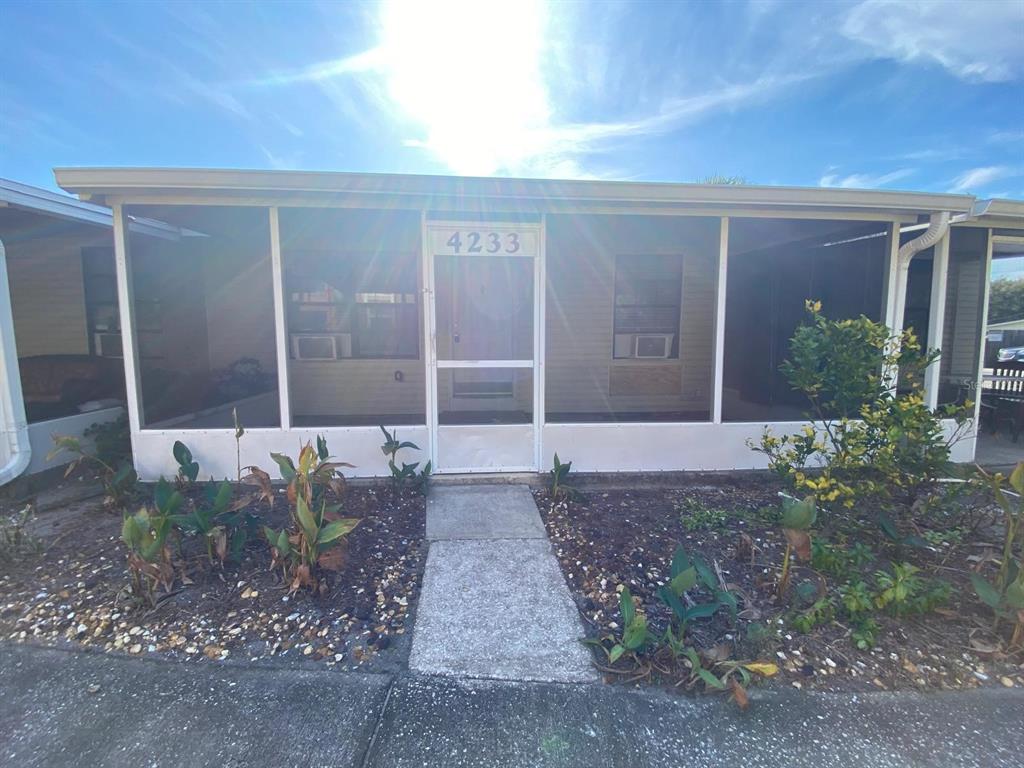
[{"left": 48, "top": 168, "right": 1024, "bottom": 480}]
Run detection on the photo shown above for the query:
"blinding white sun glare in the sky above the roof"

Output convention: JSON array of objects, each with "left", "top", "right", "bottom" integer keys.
[{"left": 380, "top": 0, "right": 550, "bottom": 175}]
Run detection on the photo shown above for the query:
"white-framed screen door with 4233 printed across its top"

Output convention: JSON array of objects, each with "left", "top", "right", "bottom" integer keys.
[{"left": 424, "top": 222, "right": 543, "bottom": 472}]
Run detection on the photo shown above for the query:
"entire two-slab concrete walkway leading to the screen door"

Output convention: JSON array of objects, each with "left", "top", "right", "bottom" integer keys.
[{"left": 409, "top": 485, "right": 597, "bottom": 683}]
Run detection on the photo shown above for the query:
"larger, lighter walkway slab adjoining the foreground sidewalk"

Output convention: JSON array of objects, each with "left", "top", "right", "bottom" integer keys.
[{"left": 409, "top": 539, "right": 597, "bottom": 682}]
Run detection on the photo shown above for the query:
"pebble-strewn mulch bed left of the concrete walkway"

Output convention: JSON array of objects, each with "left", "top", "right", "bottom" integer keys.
[{"left": 0, "top": 484, "right": 426, "bottom": 670}]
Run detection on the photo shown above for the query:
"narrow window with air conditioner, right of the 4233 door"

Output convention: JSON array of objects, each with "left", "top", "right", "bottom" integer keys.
[{"left": 612, "top": 256, "right": 683, "bottom": 359}]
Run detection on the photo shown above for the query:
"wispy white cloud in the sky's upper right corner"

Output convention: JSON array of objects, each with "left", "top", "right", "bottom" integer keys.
[{"left": 841, "top": 0, "right": 1024, "bottom": 82}]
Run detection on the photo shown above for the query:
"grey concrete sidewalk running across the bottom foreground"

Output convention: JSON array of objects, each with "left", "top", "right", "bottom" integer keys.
[{"left": 0, "top": 644, "right": 1024, "bottom": 768}]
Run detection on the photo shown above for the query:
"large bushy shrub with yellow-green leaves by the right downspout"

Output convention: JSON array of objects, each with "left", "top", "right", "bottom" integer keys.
[{"left": 751, "top": 301, "right": 974, "bottom": 508}]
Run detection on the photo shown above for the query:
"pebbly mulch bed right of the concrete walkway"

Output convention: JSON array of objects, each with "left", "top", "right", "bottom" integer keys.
[{"left": 535, "top": 476, "right": 1024, "bottom": 690}]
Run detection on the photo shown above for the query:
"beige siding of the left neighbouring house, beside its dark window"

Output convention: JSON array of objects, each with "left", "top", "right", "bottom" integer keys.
[{"left": 4, "top": 226, "right": 106, "bottom": 357}]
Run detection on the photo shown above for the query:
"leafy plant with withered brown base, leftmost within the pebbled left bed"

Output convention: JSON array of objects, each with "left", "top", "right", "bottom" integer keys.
[{"left": 121, "top": 479, "right": 184, "bottom": 604}]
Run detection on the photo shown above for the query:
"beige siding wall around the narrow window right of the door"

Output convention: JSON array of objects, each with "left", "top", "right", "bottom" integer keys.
[{"left": 545, "top": 211, "right": 719, "bottom": 421}]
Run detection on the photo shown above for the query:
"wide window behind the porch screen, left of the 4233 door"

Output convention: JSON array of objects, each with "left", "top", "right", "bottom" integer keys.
[{"left": 288, "top": 253, "right": 420, "bottom": 359}]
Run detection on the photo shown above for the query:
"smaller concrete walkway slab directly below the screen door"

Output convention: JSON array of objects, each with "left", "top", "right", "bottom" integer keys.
[{"left": 427, "top": 484, "right": 547, "bottom": 541}]
